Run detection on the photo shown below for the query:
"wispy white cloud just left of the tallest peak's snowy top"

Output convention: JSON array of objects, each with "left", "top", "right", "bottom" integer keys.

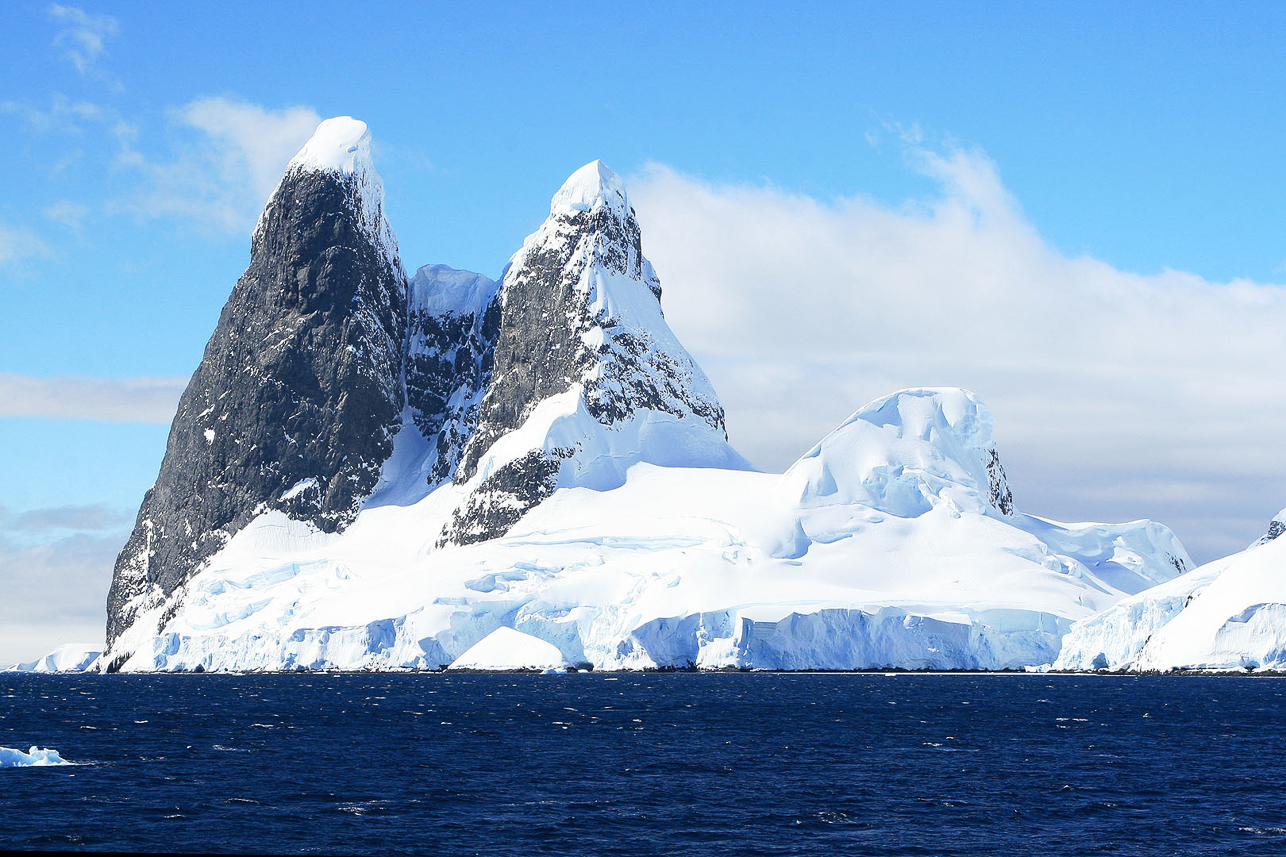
[{"left": 120, "top": 98, "right": 322, "bottom": 234}]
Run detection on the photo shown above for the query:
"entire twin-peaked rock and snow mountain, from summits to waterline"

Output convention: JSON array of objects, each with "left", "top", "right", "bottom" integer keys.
[{"left": 100, "top": 120, "right": 1188, "bottom": 670}]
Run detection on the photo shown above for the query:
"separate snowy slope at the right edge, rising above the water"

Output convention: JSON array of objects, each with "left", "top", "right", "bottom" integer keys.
[{"left": 1055, "top": 504, "right": 1286, "bottom": 672}]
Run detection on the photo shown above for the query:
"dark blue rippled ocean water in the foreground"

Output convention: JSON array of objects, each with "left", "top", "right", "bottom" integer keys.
[{"left": 0, "top": 673, "right": 1286, "bottom": 857}]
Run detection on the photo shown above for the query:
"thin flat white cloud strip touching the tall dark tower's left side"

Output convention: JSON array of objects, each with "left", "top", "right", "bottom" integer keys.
[{"left": 0, "top": 372, "right": 188, "bottom": 423}]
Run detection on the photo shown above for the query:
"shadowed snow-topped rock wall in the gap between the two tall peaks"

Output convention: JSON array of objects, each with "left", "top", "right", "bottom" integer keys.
[{"left": 406, "top": 265, "right": 500, "bottom": 486}]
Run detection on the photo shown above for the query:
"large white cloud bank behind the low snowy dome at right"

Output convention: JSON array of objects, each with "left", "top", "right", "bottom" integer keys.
[{"left": 630, "top": 148, "right": 1286, "bottom": 558}]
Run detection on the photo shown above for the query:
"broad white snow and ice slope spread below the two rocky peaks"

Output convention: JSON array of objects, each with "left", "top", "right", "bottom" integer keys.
[{"left": 97, "top": 389, "right": 1187, "bottom": 670}]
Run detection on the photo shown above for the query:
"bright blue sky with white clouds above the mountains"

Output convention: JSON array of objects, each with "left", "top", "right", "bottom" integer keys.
[{"left": 0, "top": 0, "right": 1286, "bottom": 663}]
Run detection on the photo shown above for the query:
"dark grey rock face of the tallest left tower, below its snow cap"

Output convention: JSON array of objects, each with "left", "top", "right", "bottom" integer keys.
[{"left": 107, "top": 131, "right": 406, "bottom": 642}]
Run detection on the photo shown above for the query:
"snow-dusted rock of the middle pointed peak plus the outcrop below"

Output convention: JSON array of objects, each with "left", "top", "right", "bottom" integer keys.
[{"left": 441, "top": 161, "right": 734, "bottom": 544}]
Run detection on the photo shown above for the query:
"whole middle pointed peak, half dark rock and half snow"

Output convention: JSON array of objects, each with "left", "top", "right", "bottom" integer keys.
[{"left": 441, "top": 161, "right": 748, "bottom": 544}]
